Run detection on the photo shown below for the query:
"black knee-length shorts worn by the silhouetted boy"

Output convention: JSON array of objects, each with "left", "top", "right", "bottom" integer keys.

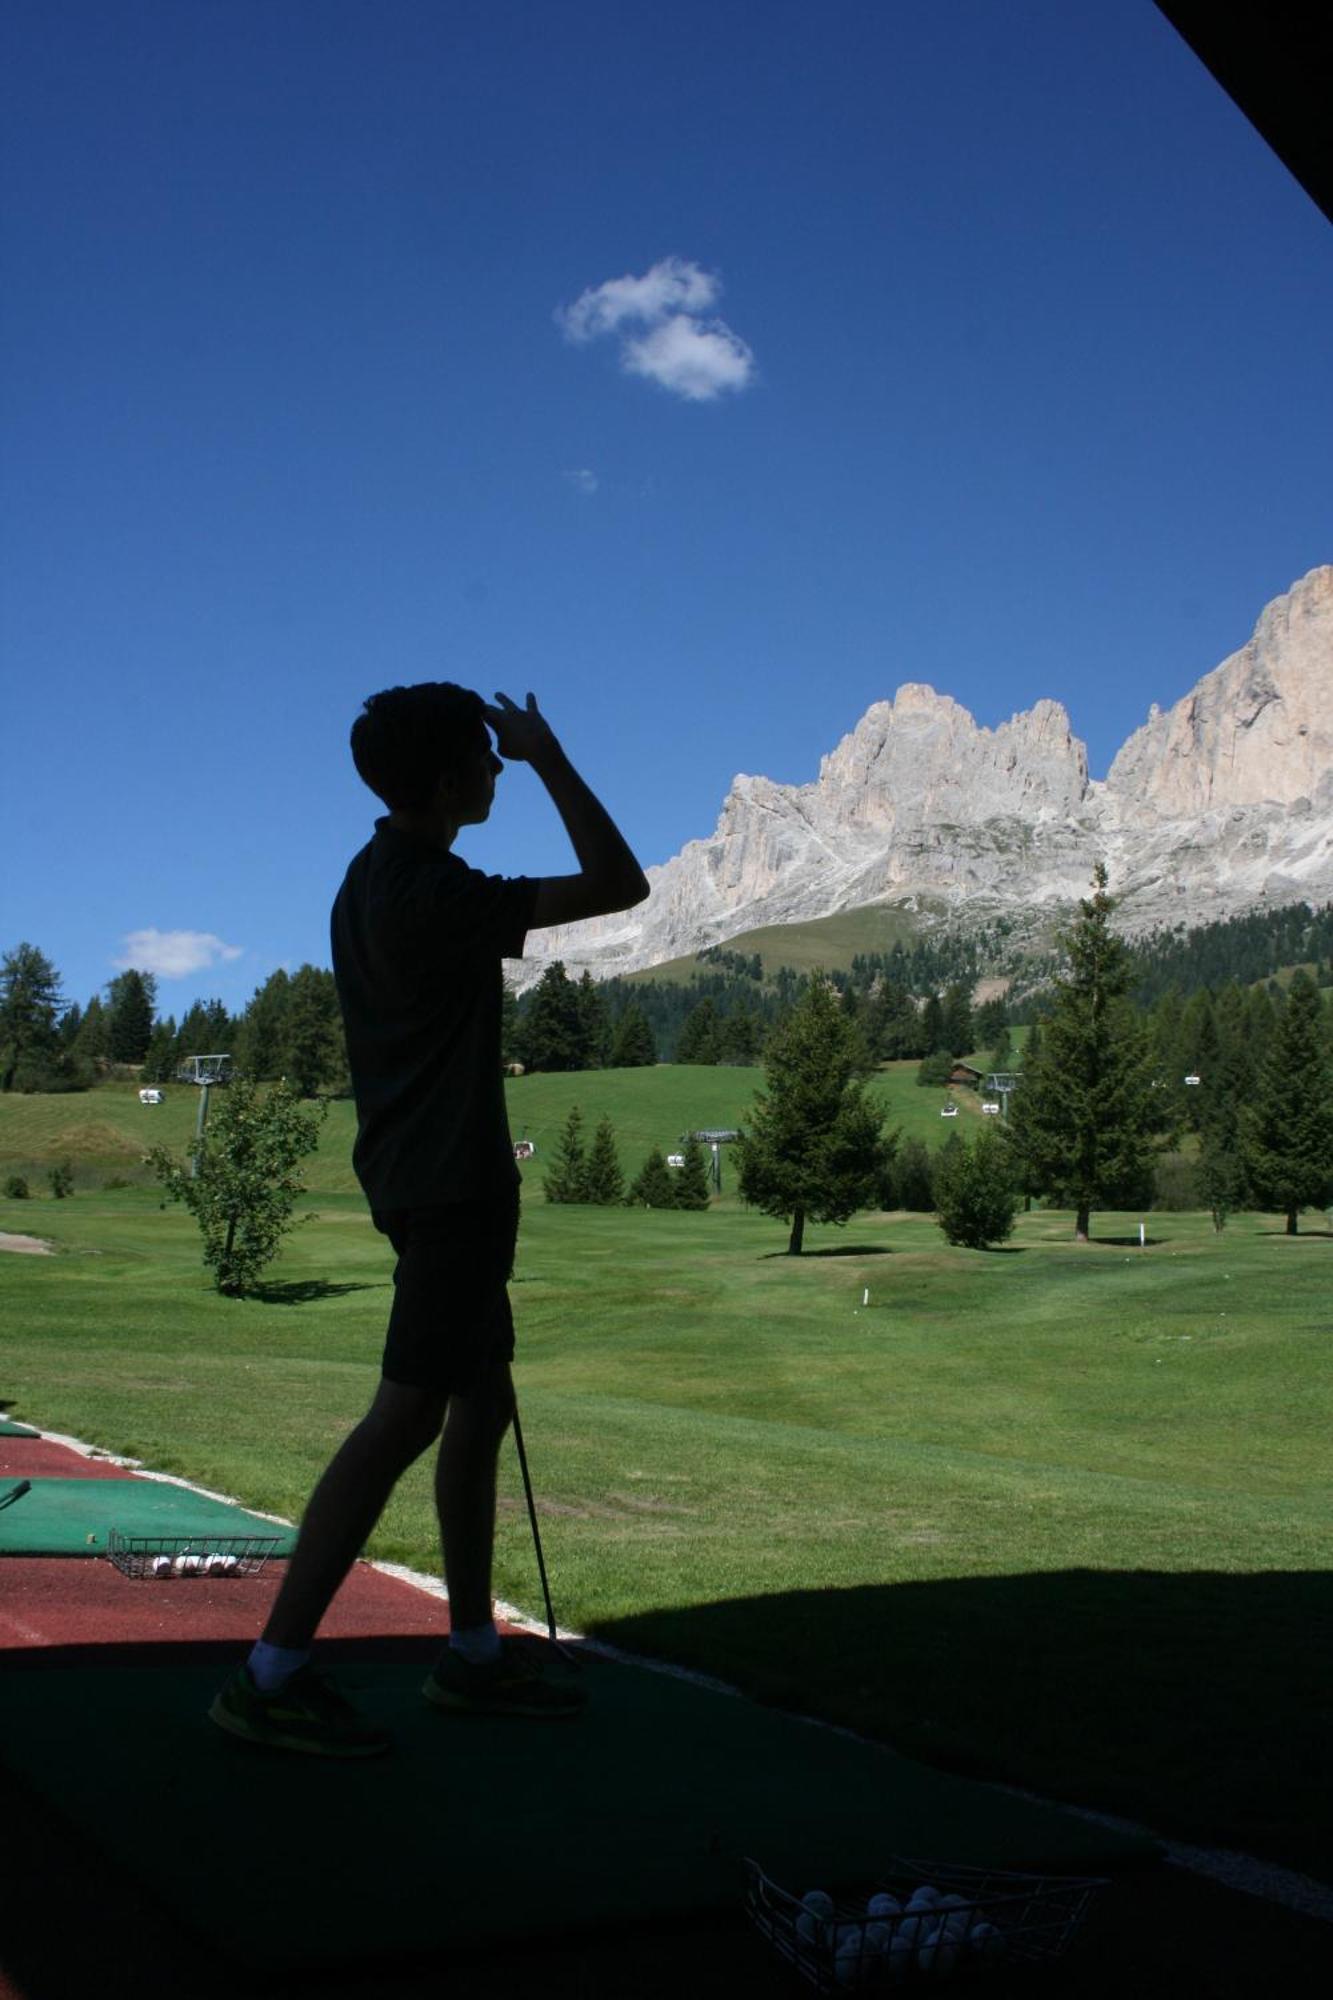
[{"left": 370, "top": 1188, "right": 518, "bottom": 1394}]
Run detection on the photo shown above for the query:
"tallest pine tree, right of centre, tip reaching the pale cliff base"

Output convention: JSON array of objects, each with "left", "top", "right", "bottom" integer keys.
[{"left": 1005, "top": 862, "right": 1171, "bottom": 1242}]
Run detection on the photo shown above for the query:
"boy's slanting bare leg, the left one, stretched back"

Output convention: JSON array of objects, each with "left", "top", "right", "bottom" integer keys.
[{"left": 264, "top": 1382, "right": 446, "bottom": 1648}]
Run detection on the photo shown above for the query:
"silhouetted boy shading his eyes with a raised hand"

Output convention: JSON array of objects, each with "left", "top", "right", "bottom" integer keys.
[{"left": 210, "top": 682, "right": 648, "bottom": 1756}]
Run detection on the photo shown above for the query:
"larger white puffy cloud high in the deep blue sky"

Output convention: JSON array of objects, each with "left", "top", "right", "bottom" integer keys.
[{"left": 556, "top": 256, "right": 755, "bottom": 402}]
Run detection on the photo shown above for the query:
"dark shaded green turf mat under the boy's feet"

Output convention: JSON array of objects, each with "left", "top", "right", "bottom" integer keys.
[{"left": 0, "top": 1660, "right": 1157, "bottom": 1990}]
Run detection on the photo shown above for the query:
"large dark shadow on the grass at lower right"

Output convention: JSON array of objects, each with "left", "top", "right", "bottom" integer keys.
[{"left": 590, "top": 1570, "right": 1333, "bottom": 1882}]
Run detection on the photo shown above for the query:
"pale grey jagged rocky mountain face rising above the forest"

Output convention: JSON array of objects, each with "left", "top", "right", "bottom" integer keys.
[{"left": 518, "top": 566, "right": 1333, "bottom": 986}]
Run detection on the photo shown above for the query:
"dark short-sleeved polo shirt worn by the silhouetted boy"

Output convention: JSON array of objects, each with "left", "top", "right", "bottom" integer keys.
[{"left": 332, "top": 818, "right": 536, "bottom": 1208}]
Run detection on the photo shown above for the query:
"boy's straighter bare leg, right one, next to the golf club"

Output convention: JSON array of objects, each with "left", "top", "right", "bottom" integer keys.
[{"left": 434, "top": 1362, "right": 514, "bottom": 1632}]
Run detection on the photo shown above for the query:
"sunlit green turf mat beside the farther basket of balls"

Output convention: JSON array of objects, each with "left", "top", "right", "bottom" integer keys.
[{"left": 0, "top": 1480, "right": 296, "bottom": 1556}]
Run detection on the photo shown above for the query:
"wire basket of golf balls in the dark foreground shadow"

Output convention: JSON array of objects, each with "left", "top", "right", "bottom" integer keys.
[{"left": 745, "top": 1860, "right": 1107, "bottom": 1994}]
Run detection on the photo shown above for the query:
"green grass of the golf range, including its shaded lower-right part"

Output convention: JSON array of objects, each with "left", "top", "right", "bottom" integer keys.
[{"left": 0, "top": 1066, "right": 1333, "bottom": 1874}]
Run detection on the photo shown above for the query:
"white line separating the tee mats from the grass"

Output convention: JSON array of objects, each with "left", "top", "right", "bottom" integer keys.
[{"left": 13, "top": 1426, "right": 1333, "bottom": 1924}]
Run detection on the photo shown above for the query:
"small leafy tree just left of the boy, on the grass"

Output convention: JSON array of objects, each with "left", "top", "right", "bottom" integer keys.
[{"left": 148, "top": 1082, "right": 328, "bottom": 1298}]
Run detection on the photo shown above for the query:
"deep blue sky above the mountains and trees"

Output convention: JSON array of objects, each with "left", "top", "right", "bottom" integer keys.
[{"left": 0, "top": 0, "right": 1333, "bottom": 1012}]
